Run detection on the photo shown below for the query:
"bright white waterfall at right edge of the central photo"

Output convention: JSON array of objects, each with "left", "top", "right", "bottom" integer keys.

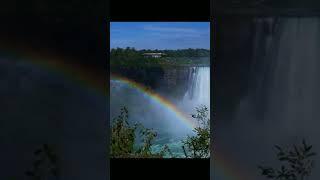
[{"left": 181, "top": 67, "right": 210, "bottom": 110}]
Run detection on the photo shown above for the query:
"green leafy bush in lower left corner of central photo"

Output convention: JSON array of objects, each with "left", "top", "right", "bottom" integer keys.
[{"left": 111, "top": 107, "right": 171, "bottom": 158}]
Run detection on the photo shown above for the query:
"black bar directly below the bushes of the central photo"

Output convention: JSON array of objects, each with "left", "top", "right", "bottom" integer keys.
[{"left": 110, "top": 159, "right": 210, "bottom": 180}]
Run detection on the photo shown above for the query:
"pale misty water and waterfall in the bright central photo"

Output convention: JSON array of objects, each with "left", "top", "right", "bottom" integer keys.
[{"left": 110, "top": 67, "right": 210, "bottom": 157}]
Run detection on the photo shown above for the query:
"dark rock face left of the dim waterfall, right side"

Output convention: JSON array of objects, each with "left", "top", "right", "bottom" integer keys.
[{"left": 212, "top": 17, "right": 256, "bottom": 122}]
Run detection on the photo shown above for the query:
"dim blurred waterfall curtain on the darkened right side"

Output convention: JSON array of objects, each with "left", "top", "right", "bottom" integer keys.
[{"left": 246, "top": 18, "right": 320, "bottom": 133}]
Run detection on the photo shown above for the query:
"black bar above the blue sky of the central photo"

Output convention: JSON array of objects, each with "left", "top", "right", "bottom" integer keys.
[{"left": 110, "top": 0, "right": 210, "bottom": 21}]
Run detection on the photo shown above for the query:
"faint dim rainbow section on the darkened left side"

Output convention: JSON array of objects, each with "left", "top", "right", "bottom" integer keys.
[{"left": 0, "top": 45, "right": 105, "bottom": 98}]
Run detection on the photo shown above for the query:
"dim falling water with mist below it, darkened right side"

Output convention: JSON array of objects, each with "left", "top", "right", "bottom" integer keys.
[{"left": 217, "top": 18, "right": 320, "bottom": 179}]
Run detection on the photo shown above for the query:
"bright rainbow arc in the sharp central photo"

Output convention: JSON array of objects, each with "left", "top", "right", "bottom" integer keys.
[{"left": 110, "top": 74, "right": 197, "bottom": 129}]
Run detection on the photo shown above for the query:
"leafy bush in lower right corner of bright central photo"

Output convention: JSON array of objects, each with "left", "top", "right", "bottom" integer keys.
[{"left": 182, "top": 105, "right": 210, "bottom": 158}]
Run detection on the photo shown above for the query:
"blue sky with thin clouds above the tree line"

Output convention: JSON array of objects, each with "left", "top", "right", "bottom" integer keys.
[{"left": 110, "top": 22, "right": 210, "bottom": 49}]
